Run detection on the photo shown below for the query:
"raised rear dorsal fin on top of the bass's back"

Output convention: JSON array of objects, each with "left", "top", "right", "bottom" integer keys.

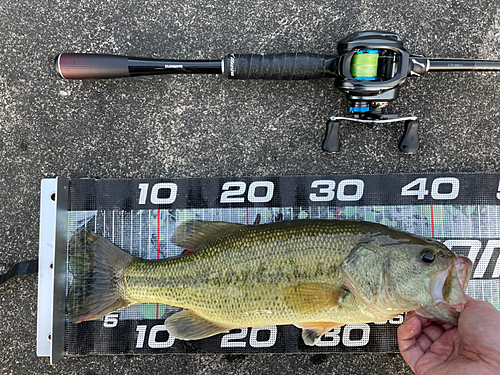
[{"left": 170, "top": 220, "right": 245, "bottom": 251}]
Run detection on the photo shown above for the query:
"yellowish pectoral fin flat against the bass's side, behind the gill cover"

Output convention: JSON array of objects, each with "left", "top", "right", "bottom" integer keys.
[{"left": 282, "top": 284, "right": 348, "bottom": 313}]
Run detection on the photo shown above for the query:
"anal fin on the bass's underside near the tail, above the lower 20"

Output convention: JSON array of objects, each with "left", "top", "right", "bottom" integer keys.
[{"left": 165, "top": 310, "right": 235, "bottom": 340}]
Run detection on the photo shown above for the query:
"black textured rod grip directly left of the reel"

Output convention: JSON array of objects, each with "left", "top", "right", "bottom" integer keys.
[{"left": 223, "top": 53, "right": 331, "bottom": 80}]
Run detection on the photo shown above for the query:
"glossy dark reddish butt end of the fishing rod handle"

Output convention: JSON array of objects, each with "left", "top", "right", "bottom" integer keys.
[{"left": 56, "top": 53, "right": 130, "bottom": 79}]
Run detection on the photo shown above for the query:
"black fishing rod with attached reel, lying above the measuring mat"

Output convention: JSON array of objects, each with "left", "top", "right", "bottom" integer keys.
[{"left": 56, "top": 31, "right": 500, "bottom": 154}]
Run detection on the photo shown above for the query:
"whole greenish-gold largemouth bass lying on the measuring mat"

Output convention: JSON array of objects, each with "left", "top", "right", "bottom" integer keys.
[{"left": 67, "top": 220, "right": 472, "bottom": 345}]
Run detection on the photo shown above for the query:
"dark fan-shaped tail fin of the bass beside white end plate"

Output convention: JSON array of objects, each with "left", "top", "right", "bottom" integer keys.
[{"left": 66, "top": 229, "right": 136, "bottom": 323}]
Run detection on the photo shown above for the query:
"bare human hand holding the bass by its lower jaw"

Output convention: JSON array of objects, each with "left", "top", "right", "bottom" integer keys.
[{"left": 398, "top": 297, "right": 500, "bottom": 375}]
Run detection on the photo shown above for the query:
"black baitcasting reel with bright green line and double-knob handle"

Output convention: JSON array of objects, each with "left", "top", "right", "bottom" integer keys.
[{"left": 323, "top": 31, "right": 429, "bottom": 154}]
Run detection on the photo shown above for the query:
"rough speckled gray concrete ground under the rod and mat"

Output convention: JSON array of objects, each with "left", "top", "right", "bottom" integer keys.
[{"left": 0, "top": 0, "right": 500, "bottom": 375}]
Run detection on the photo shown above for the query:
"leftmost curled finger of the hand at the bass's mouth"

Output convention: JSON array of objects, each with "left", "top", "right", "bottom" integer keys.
[{"left": 398, "top": 314, "right": 424, "bottom": 370}]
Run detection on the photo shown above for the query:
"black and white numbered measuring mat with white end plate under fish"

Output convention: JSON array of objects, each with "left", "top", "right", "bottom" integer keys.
[{"left": 37, "top": 174, "right": 500, "bottom": 363}]
